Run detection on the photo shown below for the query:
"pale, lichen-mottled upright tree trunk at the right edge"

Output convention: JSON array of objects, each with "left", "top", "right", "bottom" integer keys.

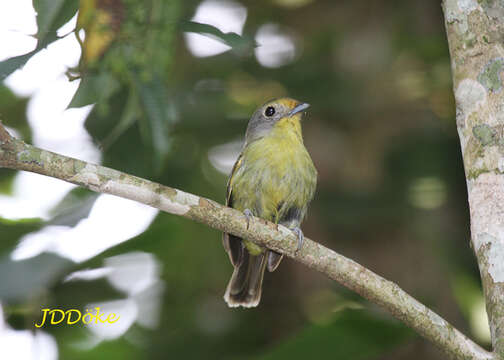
[{"left": 443, "top": 0, "right": 504, "bottom": 359}]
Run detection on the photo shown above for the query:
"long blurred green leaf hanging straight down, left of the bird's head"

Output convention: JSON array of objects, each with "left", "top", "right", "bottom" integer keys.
[{"left": 135, "top": 76, "right": 177, "bottom": 172}]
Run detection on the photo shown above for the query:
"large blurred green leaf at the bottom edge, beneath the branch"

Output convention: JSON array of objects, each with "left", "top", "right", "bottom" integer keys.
[{"left": 259, "top": 310, "right": 413, "bottom": 360}]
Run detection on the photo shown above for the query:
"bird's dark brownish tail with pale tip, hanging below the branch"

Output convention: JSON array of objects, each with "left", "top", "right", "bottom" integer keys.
[{"left": 224, "top": 250, "right": 267, "bottom": 308}]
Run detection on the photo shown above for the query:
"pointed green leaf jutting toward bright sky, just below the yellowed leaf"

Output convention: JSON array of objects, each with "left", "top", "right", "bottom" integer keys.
[{"left": 68, "top": 72, "right": 119, "bottom": 108}]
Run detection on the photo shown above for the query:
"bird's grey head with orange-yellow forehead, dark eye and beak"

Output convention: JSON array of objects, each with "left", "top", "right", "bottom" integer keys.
[{"left": 245, "top": 98, "right": 310, "bottom": 144}]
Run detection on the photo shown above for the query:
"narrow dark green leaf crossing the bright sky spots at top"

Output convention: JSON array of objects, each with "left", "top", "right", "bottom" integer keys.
[{"left": 180, "top": 21, "right": 257, "bottom": 55}]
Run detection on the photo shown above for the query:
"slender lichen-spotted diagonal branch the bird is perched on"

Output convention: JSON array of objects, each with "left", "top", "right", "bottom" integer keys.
[{"left": 0, "top": 123, "right": 493, "bottom": 360}]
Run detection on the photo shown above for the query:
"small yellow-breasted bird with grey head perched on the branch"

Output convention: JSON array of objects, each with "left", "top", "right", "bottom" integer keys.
[{"left": 222, "top": 98, "right": 317, "bottom": 307}]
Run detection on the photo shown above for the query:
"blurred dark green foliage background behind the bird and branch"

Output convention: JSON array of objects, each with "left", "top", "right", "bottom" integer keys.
[{"left": 0, "top": 0, "right": 485, "bottom": 359}]
